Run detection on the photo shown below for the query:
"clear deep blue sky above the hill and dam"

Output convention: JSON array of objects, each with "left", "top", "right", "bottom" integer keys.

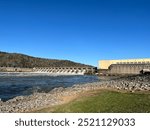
[{"left": 0, "top": 0, "right": 150, "bottom": 66}]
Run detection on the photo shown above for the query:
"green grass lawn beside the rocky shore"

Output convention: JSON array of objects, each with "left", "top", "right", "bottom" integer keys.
[{"left": 38, "top": 90, "right": 150, "bottom": 113}]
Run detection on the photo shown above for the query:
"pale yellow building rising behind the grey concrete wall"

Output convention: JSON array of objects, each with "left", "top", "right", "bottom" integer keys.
[{"left": 99, "top": 58, "right": 150, "bottom": 69}]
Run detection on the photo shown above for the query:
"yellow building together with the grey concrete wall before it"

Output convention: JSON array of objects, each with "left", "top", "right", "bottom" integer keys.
[{"left": 99, "top": 58, "right": 150, "bottom": 75}]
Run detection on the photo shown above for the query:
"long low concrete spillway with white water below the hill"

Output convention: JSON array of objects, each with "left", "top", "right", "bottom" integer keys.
[{"left": 0, "top": 67, "right": 96, "bottom": 75}]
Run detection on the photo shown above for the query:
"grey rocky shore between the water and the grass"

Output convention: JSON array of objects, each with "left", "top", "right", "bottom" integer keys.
[{"left": 0, "top": 75, "right": 150, "bottom": 113}]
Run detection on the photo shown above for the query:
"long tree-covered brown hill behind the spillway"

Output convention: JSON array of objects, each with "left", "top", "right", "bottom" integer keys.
[{"left": 0, "top": 51, "right": 91, "bottom": 68}]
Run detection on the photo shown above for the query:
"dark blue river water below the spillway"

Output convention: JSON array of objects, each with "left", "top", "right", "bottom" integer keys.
[{"left": 0, "top": 73, "right": 99, "bottom": 101}]
